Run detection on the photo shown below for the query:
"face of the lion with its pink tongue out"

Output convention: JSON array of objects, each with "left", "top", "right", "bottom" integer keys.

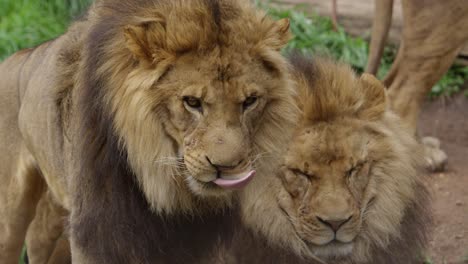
[{"left": 158, "top": 52, "right": 287, "bottom": 195}]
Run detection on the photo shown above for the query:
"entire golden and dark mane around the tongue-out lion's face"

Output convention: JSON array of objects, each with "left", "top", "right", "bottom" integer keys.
[{"left": 64, "top": 0, "right": 294, "bottom": 263}]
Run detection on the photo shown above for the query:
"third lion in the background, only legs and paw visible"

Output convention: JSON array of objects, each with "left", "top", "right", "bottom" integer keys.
[{"left": 366, "top": 0, "right": 468, "bottom": 171}]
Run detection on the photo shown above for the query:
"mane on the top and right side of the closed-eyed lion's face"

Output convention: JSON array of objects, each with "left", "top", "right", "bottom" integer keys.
[{"left": 291, "top": 55, "right": 431, "bottom": 264}]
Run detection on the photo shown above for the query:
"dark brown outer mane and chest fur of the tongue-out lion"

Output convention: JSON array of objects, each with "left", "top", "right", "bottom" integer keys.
[{"left": 70, "top": 0, "right": 245, "bottom": 263}]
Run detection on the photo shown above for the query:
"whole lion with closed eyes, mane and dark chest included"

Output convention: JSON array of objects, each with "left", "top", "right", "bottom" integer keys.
[{"left": 198, "top": 54, "right": 431, "bottom": 264}]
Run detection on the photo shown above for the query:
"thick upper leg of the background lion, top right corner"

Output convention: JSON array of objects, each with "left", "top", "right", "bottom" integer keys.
[{"left": 384, "top": 0, "right": 468, "bottom": 132}]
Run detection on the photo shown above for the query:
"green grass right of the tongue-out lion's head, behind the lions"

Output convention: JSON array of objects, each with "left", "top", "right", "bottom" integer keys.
[{"left": 264, "top": 1, "right": 468, "bottom": 98}]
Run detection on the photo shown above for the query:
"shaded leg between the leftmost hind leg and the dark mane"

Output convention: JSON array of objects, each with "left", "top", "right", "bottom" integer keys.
[{"left": 26, "top": 192, "right": 70, "bottom": 264}]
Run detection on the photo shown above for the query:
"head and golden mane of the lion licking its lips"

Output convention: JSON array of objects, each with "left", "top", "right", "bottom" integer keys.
[{"left": 78, "top": 0, "right": 294, "bottom": 211}]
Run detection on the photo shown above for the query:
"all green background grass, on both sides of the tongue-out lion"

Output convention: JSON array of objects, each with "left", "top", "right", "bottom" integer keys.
[{"left": 0, "top": 0, "right": 468, "bottom": 96}]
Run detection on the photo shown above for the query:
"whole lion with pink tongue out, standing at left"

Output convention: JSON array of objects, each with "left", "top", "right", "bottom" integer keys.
[{"left": 0, "top": 0, "right": 297, "bottom": 264}]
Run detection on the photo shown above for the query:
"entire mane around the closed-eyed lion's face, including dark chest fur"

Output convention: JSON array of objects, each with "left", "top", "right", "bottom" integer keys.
[{"left": 220, "top": 54, "right": 432, "bottom": 264}]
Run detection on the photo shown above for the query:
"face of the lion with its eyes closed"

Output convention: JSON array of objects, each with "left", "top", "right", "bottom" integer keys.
[{"left": 280, "top": 120, "right": 373, "bottom": 258}]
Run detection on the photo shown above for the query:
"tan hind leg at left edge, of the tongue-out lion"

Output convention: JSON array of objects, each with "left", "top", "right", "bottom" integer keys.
[{"left": 0, "top": 148, "right": 44, "bottom": 264}]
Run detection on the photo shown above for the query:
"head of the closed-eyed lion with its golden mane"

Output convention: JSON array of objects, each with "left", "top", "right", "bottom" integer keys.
[{"left": 279, "top": 58, "right": 427, "bottom": 263}]
